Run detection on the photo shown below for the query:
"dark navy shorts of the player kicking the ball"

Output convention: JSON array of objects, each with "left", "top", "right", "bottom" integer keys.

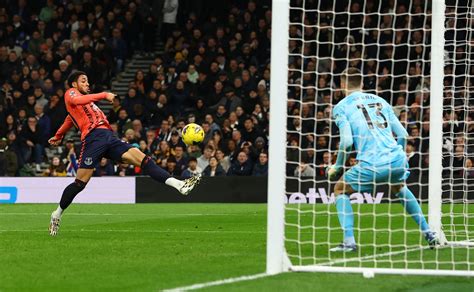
[{"left": 79, "top": 129, "right": 133, "bottom": 169}]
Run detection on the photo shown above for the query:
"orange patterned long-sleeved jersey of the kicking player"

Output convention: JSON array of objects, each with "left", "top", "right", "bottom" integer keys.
[{"left": 56, "top": 88, "right": 111, "bottom": 140}]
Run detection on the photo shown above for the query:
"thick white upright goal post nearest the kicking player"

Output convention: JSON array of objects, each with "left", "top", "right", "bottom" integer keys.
[{"left": 267, "top": 0, "right": 290, "bottom": 274}]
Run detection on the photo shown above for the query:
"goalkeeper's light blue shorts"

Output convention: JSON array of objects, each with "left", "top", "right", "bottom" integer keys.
[{"left": 344, "top": 158, "right": 410, "bottom": 193}]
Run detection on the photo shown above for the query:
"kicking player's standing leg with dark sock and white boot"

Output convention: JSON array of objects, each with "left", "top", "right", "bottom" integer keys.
[{"left": 49, "top": 168, "right": 94, "bottom": 236}]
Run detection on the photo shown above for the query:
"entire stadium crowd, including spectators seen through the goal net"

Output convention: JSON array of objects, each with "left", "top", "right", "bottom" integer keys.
[{"left": 0, "top": 0, "right": 474, "bottom": 177}]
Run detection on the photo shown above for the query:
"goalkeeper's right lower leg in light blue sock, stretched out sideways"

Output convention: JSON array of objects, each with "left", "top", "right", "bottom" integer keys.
[{"left": 391, "top": 184, "right": 439, "bottom": 248}]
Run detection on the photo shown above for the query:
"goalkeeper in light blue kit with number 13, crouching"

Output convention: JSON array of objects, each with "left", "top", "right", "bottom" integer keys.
[{"left": 328, "top": 68, "right": 439, "bottom": 252}]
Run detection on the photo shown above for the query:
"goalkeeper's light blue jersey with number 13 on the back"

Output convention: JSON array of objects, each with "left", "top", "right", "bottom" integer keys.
[{"left": 333, "top": 91, "right": 406, "bottom": 165}]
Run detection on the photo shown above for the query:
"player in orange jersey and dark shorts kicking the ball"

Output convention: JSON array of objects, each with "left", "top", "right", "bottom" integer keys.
[{"left": 49, "top": 71, "right": 200, "bottom": 236}]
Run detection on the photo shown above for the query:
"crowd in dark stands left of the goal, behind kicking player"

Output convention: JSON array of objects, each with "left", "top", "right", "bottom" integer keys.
[{"left": 0, "top": 0, "right": 271, "bottom": 177}]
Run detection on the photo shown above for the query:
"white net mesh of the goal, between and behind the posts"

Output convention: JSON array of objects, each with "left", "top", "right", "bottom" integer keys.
[{"left": 285, "top": 0, "right": 474, "bottom": 270}]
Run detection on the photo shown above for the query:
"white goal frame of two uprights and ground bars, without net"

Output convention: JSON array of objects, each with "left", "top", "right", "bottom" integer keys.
[{"left": 266, "top": 0, "right": 474, "bottom": 277}]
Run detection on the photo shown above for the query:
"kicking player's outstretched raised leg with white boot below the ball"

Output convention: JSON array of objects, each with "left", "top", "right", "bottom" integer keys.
[{"left": 122, "top": 148, "right": 201, "bottom": 195}]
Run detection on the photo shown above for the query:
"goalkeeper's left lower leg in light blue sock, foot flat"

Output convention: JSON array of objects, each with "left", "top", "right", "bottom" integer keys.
[{"left": 330, "top": 178, "right": 357, "bottom": 252}]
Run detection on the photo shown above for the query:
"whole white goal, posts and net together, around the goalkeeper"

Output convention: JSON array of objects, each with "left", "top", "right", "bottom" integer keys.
[{"left": 267, "top": 0, "right": 474, "bottom": 276}]
